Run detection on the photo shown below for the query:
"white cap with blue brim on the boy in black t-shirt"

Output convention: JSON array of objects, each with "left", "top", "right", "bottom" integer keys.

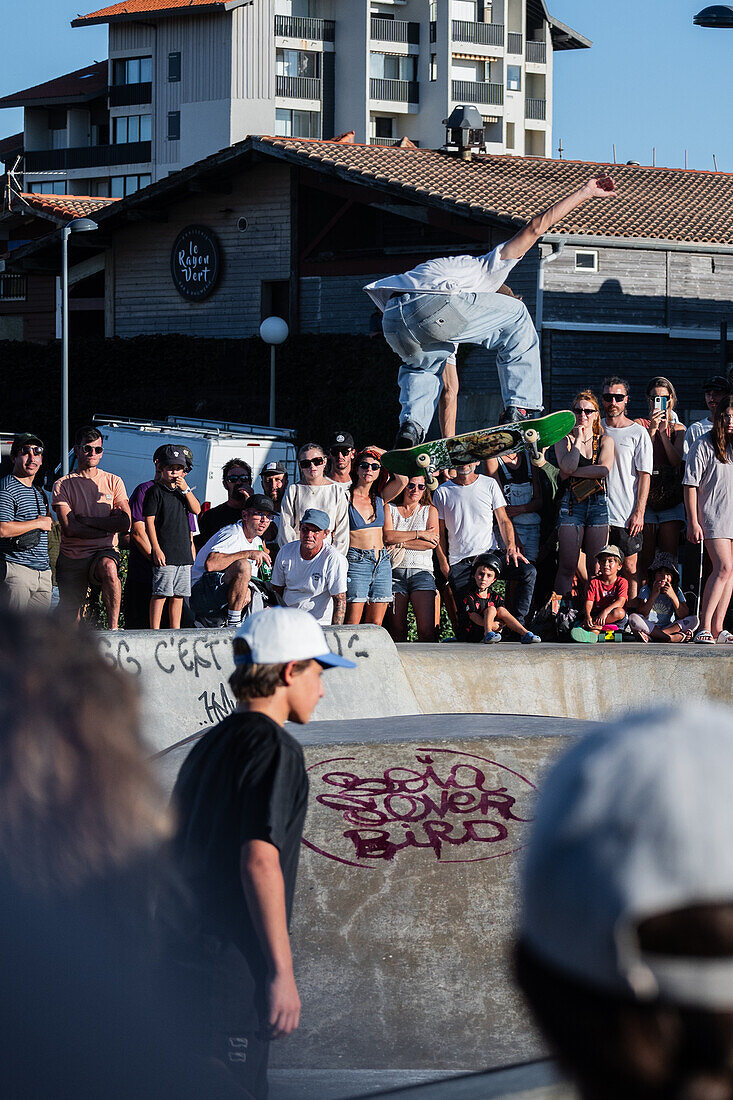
[{"left": 234, "top": 607, "right": 357, "bottom": 669}]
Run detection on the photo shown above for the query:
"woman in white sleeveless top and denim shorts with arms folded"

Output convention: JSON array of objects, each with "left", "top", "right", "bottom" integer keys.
[{"left": 384, "top": 474, "right": 438, "bottom": 641}]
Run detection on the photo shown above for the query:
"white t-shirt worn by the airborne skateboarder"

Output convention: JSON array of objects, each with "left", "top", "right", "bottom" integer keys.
[{"left": 364, "top": 243, "right": 519, "bottom": 312}]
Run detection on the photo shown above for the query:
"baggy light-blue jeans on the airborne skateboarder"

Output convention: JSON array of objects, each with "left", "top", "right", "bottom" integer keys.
[{"left": 382, "top": 293, "right": 543, "bottom": 431}]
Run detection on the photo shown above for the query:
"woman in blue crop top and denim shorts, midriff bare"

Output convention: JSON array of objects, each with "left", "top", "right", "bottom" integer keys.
[{"left": 344, "top": 447, "right": 392, "bottom": 626}]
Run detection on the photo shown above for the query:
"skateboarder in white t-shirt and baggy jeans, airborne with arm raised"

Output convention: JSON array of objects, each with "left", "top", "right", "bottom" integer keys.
[{"left": 364, "top": 176, "right": 616, "bottom": 449}]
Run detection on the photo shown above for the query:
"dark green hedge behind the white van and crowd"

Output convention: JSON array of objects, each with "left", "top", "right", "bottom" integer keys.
[{"left": 0, "top": 327, "right": 400, "bottom": 463}]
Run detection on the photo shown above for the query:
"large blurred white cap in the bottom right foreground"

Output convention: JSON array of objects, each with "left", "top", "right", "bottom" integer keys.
[{"left": 521, "top": 702, "right": 733, "bottom": 1010}]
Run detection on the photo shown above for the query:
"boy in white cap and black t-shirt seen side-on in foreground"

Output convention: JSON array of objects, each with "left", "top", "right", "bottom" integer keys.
[{"left": 172, "top": 607, "right": 354, "bottom": 1100}]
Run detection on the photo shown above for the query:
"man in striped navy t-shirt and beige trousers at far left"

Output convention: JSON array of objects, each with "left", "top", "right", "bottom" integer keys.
[{"left": 0, "top": 432, "right": 52, "bottom": 611}]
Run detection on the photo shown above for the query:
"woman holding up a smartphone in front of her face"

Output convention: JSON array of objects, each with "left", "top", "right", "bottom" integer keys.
[{"left": 636, "top": 375, "right": 685, "bottom": 572}]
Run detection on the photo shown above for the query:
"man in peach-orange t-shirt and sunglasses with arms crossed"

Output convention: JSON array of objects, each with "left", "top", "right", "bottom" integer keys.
[{"left": 53, "top": 427, "right": 130, "bottom": 630}]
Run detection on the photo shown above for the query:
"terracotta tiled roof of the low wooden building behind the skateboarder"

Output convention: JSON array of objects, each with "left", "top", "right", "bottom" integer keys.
[{"left": 258, "top": 138, "right": 733, "bottom": 244}]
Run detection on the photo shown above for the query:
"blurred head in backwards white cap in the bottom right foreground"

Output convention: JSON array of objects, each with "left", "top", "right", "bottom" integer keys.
[{"left": 516, "top": 704, "right": 733, "bottom": 1100}]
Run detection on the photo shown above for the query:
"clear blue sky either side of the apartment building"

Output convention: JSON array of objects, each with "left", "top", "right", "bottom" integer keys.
[{"left": 0, "top": 0, "right": 733, "bottom": 172}]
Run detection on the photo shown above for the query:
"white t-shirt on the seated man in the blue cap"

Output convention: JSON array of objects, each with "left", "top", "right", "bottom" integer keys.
[{"left": 272, "top": 540, "right": 349, "bottom": 626}]
